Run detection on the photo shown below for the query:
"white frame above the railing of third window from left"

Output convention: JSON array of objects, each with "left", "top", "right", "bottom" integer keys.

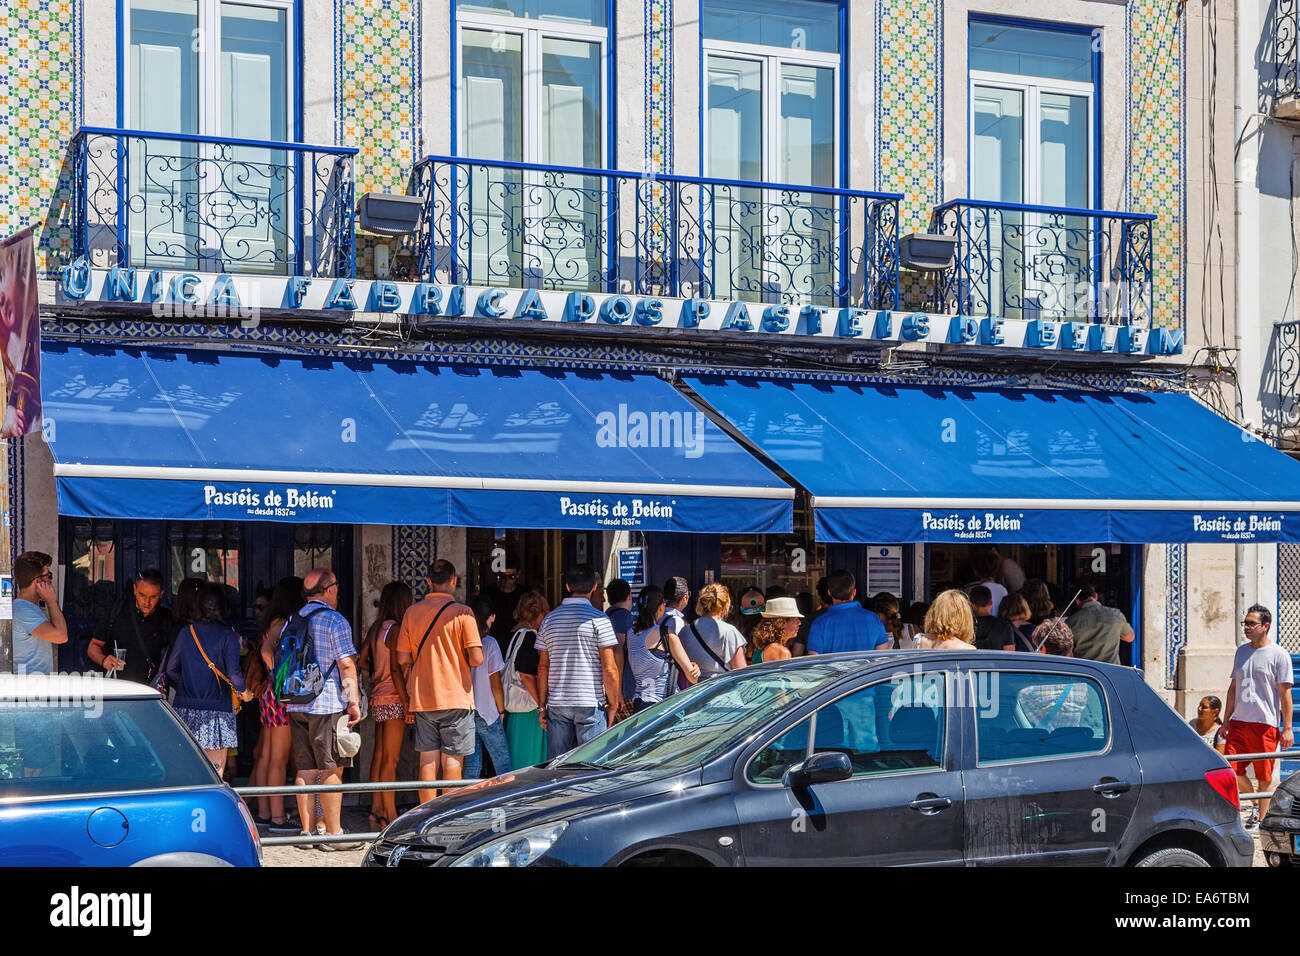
[{"left": 699, "top": 39, "right": 844, "bottom": 189}]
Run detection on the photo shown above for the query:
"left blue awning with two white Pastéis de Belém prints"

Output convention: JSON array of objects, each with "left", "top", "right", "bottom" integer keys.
[{"left": 42, "top": 342, "right": 794, "bottom": 533}]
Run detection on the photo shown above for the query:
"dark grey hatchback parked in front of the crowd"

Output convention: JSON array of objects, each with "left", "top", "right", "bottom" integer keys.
[{"left": 365, "top": 650, "right": 1253, "bottom": 866}]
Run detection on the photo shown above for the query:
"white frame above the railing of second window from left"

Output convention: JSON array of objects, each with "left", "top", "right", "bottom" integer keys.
[{"left": 452, "top": 8, "right": 610, "bottom": 169}]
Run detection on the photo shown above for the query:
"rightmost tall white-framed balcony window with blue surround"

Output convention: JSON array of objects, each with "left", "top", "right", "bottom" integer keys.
[{"left": 969, "top": 21, "right": 1097, "bottom": 319}]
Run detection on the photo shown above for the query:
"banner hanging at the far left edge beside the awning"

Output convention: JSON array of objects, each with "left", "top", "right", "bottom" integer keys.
[{"left": 0, "top": 229, "right": 40, "bottom": 438}]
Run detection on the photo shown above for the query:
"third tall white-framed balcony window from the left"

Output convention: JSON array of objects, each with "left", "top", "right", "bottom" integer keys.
[{"left": 701, "top": 0, "right": 840, "bottom": 300}]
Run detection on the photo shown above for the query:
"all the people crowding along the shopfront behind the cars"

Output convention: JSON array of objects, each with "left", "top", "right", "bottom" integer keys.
[{"left": 7, "top": 551, "right": 1294, "bottom": 848}]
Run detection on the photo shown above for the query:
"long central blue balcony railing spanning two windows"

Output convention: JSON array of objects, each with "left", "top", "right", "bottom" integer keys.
[{"left": 411, "top": 156, "right": 901, "bottom": 308}]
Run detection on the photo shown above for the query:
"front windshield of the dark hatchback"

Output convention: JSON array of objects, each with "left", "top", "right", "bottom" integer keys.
[{"left": 556, "top": 659, "right": 862, "bottom": 769}]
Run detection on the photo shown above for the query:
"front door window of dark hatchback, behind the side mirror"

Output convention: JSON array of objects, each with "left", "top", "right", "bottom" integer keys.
[{"left": 813, "top": 671, "right": 946, "bottom": 777}]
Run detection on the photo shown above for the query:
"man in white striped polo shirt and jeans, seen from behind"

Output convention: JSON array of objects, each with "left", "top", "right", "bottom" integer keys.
[{"left": 537, "top": 564, "right": 619, "bottom": 760}]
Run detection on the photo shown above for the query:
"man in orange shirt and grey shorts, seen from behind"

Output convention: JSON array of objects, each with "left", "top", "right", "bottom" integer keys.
[{"left": 398, "top": 558, "right": 484, "bottom": 803}]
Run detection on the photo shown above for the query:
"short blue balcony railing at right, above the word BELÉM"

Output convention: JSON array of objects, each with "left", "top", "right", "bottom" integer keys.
[{"left": 930, "top": 199, "right": 1156, "bottom": 325}]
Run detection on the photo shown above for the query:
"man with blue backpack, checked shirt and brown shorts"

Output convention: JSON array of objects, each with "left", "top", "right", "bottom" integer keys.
[{"left": 279, "top": 568, "right": 361, "bottom": 851}]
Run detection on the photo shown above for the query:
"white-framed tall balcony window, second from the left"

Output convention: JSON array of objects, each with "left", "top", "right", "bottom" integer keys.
[{"left": 455, "top": 0, "right": 611, "bottom": 291}]
